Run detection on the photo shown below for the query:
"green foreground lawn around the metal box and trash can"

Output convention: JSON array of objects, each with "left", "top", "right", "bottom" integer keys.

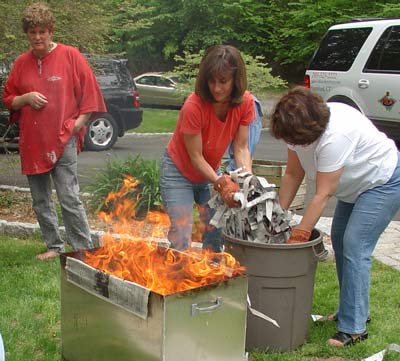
[{"left": 0, "top": 236, "right": 400, "bottom": 361}]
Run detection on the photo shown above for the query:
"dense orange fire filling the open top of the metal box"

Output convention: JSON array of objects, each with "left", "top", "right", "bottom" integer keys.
[{"left": 85, "top": 238, "right": 244, "bottom": 295}]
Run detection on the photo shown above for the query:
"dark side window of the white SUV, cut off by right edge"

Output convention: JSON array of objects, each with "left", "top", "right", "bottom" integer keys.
[{"left": 364, "top": 26, "right": 400, "bottom": 73}]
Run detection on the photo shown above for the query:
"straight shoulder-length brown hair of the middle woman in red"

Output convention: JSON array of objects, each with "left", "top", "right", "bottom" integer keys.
[{"left": 195, "top": 45, "right": 247, "bottom": 106}]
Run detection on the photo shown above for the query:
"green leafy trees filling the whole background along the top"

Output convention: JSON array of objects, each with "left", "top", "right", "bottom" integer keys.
[{"left": 0, "top": 0, "right": 400, "bottom": 80}]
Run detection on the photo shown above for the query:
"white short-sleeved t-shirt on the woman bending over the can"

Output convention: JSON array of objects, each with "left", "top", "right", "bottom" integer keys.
[{"left": 288, "top": 103, "right": 398, "bottom": 203}]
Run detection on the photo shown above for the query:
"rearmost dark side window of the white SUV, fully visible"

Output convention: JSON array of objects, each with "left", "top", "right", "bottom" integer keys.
[{"left": 309, "top": 28, "right": 372, "bottom": 71}]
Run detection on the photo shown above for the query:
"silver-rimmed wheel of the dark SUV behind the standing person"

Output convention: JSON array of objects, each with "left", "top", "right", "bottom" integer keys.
[{"left": 85, "top": 113, "right": 118, "bottom": 151}]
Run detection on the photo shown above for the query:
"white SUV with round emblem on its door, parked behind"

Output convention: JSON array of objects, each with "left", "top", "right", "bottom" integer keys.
[{"left": 304, "top": 19, "right": 400, "bottom": 144}]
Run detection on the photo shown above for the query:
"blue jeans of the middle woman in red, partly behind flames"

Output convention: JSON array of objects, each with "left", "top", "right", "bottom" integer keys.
[{"left": 160, "top": 151, "right": 222, "bottom": 252}]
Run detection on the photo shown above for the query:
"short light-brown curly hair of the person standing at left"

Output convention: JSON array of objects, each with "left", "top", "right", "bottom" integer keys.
[{"left": 22, "top": 3, "right": 56, "bottom": 33}]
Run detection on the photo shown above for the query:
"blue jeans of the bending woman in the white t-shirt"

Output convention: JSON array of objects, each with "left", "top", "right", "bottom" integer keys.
[{"left": 331, "top": 151, "right": 400, "bottom": 334}]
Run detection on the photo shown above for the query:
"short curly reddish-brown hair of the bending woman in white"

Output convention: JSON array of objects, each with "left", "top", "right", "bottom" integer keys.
[{"left": 270, "top": 86, "right": 331, "bottom": 145}]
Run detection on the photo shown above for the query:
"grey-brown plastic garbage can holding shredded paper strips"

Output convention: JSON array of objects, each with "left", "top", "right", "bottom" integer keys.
[{"left": 223, "top": 229, "right": 327, "bottom": 351}]
